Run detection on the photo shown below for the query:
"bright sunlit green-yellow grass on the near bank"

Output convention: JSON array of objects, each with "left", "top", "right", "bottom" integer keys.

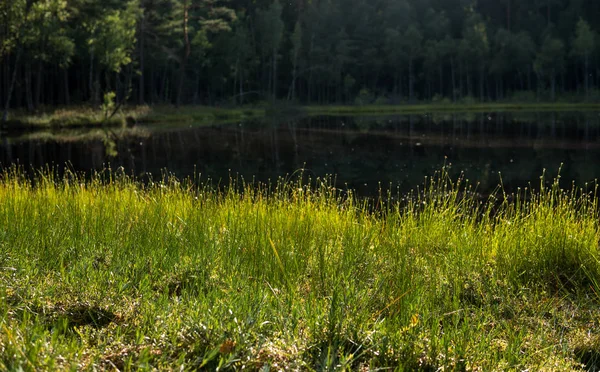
[{"left": 0, "top": 171, "right": 600, "bottom": 371}]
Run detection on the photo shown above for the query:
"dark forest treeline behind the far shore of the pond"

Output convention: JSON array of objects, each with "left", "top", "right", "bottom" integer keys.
[{"left": 0, "top": 0, "right": 600, "bottom": 115}]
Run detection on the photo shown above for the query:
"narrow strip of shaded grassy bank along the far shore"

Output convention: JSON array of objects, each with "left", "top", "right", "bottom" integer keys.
[{"left": 3, "top": 103, "right": 600, "bottom": 129}]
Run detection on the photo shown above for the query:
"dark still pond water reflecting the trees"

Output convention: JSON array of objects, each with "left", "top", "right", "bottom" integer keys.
[{"left": 0, "top": 112, "right": 600, "bottom": 195}]
